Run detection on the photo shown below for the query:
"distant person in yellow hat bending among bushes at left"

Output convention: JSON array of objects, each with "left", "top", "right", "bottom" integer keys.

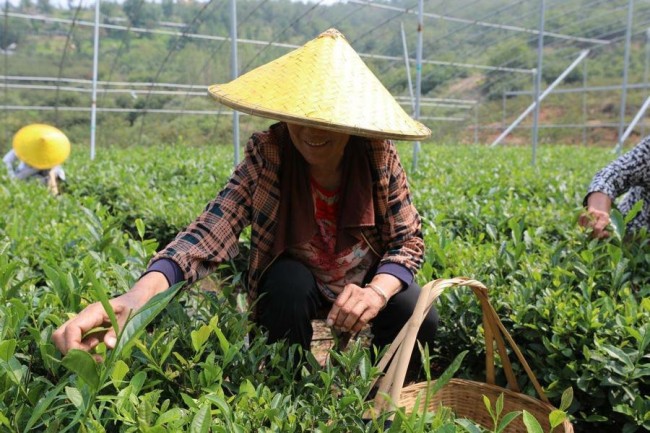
[{"left": 2, "top": 123, "right": 70, "bottom": 195}]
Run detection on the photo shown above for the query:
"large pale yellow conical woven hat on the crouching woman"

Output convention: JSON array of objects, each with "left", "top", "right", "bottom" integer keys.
[{"left": 208, "top": 29, "right": 431, "bottom": 140}]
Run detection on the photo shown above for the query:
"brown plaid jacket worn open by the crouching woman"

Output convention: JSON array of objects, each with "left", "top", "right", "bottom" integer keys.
[{"left": 150, "top": 123, "right": 424, "bottom": 300}]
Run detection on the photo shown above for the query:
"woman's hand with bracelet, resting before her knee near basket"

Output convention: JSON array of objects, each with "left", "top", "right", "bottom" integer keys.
[{"left": 327, "top": 284, "right": 384, "bottom": 332}]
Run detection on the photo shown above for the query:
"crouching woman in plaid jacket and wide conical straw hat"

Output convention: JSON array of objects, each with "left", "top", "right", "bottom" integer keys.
[{"left": 52, "top": 29, "right": 438, "bottom": 376}]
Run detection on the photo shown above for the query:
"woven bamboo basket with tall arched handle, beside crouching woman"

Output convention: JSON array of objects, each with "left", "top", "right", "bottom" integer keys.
[{"left": 373, "top": 277, "right": 573, "bottom": 433}]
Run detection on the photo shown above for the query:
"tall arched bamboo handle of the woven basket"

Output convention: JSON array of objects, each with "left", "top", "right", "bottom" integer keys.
[{"left": 371, "top": 277, "right": 549, "bottom": 412}]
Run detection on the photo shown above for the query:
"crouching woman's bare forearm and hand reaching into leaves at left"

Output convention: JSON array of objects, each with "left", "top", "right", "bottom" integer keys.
[{"left": 52, "top": 272, "right": 169, "bottom": 361}]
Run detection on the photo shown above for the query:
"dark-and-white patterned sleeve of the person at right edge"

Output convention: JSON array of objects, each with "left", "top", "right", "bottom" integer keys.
[{"left": 584, "top": 136, "right": 650, "bottom": 231}]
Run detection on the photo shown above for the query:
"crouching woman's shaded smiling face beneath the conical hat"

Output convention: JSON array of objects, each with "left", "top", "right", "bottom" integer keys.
[{"left": 287, "top": 123, "right": 350, "bottom": 171}]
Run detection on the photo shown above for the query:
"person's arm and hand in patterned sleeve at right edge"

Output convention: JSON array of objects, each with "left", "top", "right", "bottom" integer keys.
[{"left": 578, "top": 137, "right": 650, "bottom": 239}]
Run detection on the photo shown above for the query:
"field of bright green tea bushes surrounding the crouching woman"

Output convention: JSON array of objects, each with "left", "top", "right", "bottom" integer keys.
[{"left": 0, "top": 144, "right": 650, "bottom": 433}]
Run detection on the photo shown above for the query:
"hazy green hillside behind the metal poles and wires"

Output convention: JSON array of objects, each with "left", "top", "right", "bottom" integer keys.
[{"left": 0, "top": 0, "right": 650, "bottom": 147}]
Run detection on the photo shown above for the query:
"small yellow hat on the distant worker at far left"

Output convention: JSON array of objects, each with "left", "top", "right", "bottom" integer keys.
[{"left": 13, "top": 123, "right": 70, "bottom": 170}]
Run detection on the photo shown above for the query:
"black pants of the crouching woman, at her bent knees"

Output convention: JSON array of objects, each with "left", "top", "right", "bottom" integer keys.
[{"left": 257, "top": 257, "right": 438, "bottom": 369}]
